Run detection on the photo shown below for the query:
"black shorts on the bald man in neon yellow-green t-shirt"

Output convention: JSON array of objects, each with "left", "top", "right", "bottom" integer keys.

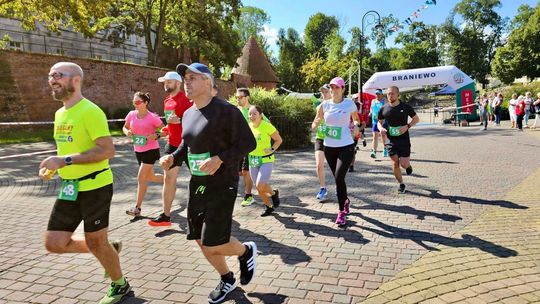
[{"left": 47, "top": 184, "right": 113, "bottom": 232}]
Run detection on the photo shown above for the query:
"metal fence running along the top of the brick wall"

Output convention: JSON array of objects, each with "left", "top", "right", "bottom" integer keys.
[{"left": 0, "top": 29, "right": 147, "bottom": 64}]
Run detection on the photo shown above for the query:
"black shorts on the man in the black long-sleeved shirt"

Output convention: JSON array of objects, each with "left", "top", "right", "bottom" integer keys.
[{"left": 187, "top": 181, "right": 238, "bottom": 246}]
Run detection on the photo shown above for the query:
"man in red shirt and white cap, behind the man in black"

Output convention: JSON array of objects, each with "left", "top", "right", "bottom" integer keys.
[{"left": 148, "top": 72, "right": 193, "bottom": 226}]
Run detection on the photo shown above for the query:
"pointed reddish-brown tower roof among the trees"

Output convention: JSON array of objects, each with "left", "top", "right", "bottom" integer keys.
[{"left": 232, "top": 36, "right": 279, "bottom": 83}]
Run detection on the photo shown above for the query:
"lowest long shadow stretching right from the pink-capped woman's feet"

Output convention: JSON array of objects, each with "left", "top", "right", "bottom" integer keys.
[{"left": 357, "top": 214, "right": 518, "bottom": 258}]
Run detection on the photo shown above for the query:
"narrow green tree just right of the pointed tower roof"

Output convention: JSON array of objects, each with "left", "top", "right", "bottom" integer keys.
[{"left": 276, "top": 28, "right": 306, "bottom": 91}]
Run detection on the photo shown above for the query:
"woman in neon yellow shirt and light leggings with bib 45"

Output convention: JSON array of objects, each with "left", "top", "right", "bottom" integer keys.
[{"left": 248, "top": 106, "right": 283, "bottom": 216}]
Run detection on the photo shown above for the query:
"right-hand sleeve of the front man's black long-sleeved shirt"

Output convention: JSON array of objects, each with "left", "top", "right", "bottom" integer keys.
[{"left": 218, "top": 107, "right": 257, "bottom": 162}]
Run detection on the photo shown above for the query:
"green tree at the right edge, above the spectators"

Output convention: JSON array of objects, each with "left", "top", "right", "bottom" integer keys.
[{"left": 492, "top": 4, "right": 540, "bottom": 83}]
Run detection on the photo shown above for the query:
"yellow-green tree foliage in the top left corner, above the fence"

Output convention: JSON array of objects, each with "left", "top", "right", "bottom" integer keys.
[{"left": 0, "top": 0, "right": 110, "bottom": 37}]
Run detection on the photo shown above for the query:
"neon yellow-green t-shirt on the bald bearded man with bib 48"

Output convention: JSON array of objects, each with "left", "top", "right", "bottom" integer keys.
[{"left": 54, "top": 98, "right": 113, "bottom": 191}]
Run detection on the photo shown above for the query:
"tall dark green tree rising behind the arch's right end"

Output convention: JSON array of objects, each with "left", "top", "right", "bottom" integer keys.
[{"left": 442, "top": 0, "right": 506, "bottom": 85}]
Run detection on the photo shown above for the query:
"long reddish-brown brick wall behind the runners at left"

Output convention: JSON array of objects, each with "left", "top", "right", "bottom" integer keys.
[{"left": 0, "top": 51, "right": 262, "bottom": 122}]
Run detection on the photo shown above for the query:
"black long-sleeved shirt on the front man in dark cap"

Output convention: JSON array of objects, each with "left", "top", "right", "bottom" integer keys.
[{"left": 173, "top": 97, "right": 257, "bottom": 187}]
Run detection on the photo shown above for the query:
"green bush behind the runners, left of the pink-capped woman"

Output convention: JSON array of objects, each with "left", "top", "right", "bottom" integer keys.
[{"left": 229, "top": 88, "right": 315, "bottom": 149}]
